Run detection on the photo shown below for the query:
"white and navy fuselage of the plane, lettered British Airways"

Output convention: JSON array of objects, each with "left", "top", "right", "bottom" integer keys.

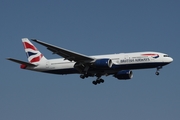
[{"left": 26, "top": 52, "right": 173, "bottom": 74}]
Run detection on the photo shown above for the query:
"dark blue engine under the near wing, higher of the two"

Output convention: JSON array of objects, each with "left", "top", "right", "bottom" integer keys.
[{"left": 93, "top": 58, "right": 113, "bottom": 69}]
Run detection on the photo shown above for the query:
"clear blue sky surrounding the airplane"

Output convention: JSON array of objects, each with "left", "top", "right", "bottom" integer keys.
[{"left": 0, "top": 0, "right": 180, "bottom": 120}]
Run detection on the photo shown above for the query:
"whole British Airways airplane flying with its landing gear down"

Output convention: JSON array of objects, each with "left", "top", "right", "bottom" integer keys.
[{"left": 7, "top": 38, "right": 173, "bottom": 85}]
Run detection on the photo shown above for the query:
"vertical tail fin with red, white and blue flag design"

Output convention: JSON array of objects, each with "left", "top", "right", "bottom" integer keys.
[{"left": 22, "top": 38, "right": 47, "bottom": 63}]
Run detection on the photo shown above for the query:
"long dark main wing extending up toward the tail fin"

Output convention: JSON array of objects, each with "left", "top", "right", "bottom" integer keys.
[{"left": 32, "top": 39, "right": 95, "bottom": 62}]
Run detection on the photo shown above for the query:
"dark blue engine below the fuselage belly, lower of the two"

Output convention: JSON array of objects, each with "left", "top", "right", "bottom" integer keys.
[{"left": 114, "top": 70, "right": 133, "bottom": 80}]
